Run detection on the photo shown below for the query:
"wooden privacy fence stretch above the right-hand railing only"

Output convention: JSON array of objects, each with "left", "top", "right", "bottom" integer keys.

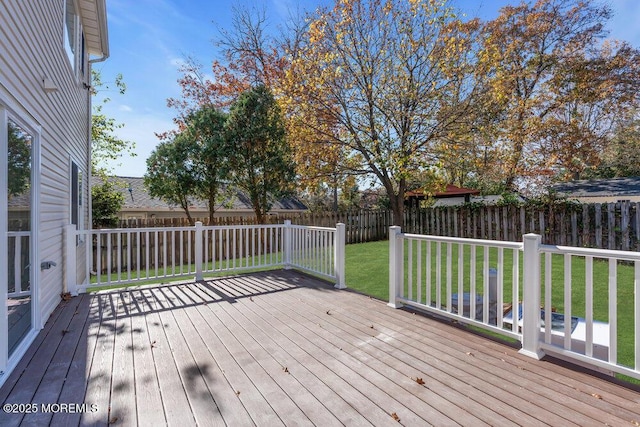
[{"left": 404, "top": 202, "right": 640, "bottom": 251}]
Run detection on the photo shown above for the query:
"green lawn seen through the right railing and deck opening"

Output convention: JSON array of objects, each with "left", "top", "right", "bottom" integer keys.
[{"left": 346, "top": 241, "right": 637, "bottom": 382}]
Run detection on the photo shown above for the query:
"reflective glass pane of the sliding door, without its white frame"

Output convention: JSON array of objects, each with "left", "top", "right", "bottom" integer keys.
[{"left": 5, "top": 117, "right": 34, "bottom": 358}]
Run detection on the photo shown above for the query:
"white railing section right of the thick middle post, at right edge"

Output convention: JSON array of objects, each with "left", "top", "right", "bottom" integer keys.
[{"left": 538, "top": 245, "right": 640, "bottom": 378}]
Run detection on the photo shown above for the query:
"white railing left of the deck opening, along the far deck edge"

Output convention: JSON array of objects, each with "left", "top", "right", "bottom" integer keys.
[{"left": 66, "top": 221, "right": 345, "bottom": 294}]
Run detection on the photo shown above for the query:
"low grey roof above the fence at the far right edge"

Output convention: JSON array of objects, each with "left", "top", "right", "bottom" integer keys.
[{"left": 553, "top": 176, "right": 640, "bottom": 197}]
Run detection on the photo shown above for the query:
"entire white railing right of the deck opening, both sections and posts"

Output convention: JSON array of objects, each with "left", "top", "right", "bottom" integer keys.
[{"left": 389, "top": 227, "right": 640, "bottom": 378}]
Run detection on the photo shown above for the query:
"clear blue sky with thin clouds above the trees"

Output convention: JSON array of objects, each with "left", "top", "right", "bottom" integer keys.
[{"left": 94, "top": 0, "right": 640, "bottom": 177}]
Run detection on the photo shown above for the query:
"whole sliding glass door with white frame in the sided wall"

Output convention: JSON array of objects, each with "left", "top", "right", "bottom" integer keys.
[{"left": 0, "top": 104, "right": 39, "bottom": 371}]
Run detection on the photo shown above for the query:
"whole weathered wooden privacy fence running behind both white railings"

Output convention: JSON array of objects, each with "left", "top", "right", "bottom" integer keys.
[{"left": 111, "top": 202, "right": 640, "bottom": 251}]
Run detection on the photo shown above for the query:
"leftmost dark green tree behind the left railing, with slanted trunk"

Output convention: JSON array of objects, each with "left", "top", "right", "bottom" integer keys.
[{"left": 144, "top": 133, "right": 199, "bottom": 225}]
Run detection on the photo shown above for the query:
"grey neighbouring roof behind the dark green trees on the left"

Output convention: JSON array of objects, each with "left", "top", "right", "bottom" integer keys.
[{"left": 98, "top": 176, "right": 307, "bottom": 211}]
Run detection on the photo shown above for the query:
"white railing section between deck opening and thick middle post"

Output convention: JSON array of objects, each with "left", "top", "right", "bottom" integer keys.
[{"left": 389, "top": 227, "right": 522, "bottom": 339}]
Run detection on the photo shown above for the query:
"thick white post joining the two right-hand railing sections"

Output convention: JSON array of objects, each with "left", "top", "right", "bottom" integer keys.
[{"left": 513, "top": 233, "right": 544, "bottom": 359}]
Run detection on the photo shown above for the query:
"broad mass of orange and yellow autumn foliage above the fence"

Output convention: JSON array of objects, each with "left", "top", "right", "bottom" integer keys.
[{"left": 162, "top": 0, "right": 640, "bottom": 224}]
